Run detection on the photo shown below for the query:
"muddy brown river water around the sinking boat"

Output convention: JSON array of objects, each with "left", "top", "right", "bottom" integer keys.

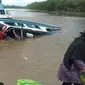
[{"left": 0, "top": 9, "right": 85, "bottom": 85}]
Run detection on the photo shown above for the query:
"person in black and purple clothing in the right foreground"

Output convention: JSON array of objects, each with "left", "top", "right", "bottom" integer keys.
[{"left": 57, "top": 31, "right": 85, "bottom": 85}]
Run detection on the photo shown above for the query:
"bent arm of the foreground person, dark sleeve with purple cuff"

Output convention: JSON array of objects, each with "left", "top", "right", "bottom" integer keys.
[{"left": 71, "top": 42, "right": 85, "bottom": 70}]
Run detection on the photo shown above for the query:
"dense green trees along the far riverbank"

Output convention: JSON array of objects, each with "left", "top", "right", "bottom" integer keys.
[{"left": 25, "top": 0, "right": 85, "bottom": 12}]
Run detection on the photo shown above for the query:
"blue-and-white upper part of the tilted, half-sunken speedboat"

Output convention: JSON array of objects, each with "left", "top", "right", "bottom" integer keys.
[{"left": 0, "top": 18, "right": 61, "bottom": 35}]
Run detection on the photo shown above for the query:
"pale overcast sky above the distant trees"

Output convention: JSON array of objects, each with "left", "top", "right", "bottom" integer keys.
[{"left": 2, "top": 0, "right": 46, "bottom": 6}]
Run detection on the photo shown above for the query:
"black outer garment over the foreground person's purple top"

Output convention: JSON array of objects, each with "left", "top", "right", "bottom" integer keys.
[{"left": 64, "top": 37, "right": 85, "bottom": 69}]
